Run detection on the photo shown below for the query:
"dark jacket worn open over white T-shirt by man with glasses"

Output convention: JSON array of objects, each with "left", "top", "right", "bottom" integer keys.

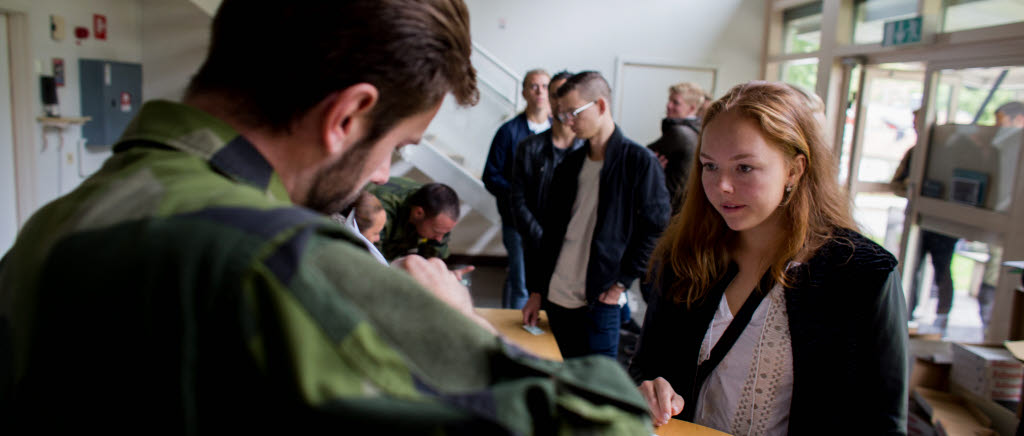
[{"left": 526, "top": 126, "right": 669, "bottom": 303}]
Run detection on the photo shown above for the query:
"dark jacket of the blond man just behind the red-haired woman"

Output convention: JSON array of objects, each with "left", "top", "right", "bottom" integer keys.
[{"left": 647, "top": 118, "right": 700, "bottom": 215}]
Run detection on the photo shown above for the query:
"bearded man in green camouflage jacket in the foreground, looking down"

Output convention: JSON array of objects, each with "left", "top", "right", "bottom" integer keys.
[{"left": 0, "top": 0, "right": 650, "bottom": 434}]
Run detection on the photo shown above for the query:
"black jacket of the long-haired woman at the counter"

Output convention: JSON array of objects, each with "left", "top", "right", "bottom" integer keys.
[{"left": 630, "top": 230, "right": 907, "bottom": 435}]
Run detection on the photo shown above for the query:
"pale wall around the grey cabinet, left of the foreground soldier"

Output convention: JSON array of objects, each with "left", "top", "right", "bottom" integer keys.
[{"left": 0, "top": 0, "right": 142, "bottom": 214}]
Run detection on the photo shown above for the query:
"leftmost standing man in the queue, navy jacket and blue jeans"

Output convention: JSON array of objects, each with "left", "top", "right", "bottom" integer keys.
[{"left": 483, "top": 70, "right": 551, "bottom": 309}]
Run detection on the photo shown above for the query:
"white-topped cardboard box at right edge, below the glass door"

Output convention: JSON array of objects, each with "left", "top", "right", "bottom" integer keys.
[{"left": 951, "top": 344, "right": 1024, "bottom": 401}]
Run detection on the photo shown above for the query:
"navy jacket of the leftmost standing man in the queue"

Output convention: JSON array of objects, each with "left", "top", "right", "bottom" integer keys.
[{"left": 482, "top": 113, "right": 532, "bottom": 221}]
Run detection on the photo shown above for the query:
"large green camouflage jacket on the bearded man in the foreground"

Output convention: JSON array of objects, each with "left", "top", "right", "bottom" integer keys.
[{"left": 0, "top": 101, "right": 650, "bottom": 434}]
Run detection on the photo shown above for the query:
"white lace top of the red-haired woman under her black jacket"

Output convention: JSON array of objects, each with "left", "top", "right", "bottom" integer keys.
[{"left": 694, "top": 285, "right": 793, "bottom": 436}]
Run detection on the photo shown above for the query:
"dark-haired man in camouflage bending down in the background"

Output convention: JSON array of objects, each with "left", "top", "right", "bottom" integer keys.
[{"left": 367, "top": 177, "right": 459, "bottom": 261}]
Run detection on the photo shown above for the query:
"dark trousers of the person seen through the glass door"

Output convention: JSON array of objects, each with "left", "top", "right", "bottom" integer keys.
[{"left": 907, "top": 230, "right": 956, "bottom": 317}]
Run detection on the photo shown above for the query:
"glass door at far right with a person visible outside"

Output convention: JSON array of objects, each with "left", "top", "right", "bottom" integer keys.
[{"left": 901, "top": 58, "right": 1024, "bottom": 341}]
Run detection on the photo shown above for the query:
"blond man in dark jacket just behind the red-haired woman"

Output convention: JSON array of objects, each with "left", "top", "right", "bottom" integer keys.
[{"left": 647, "top": 82, "right": 705, "bottom": 215}]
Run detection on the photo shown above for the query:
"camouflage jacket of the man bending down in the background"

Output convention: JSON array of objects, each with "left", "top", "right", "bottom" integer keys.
[{"left": 368, "top": 177, "right": 452, "bottom": 262}]
